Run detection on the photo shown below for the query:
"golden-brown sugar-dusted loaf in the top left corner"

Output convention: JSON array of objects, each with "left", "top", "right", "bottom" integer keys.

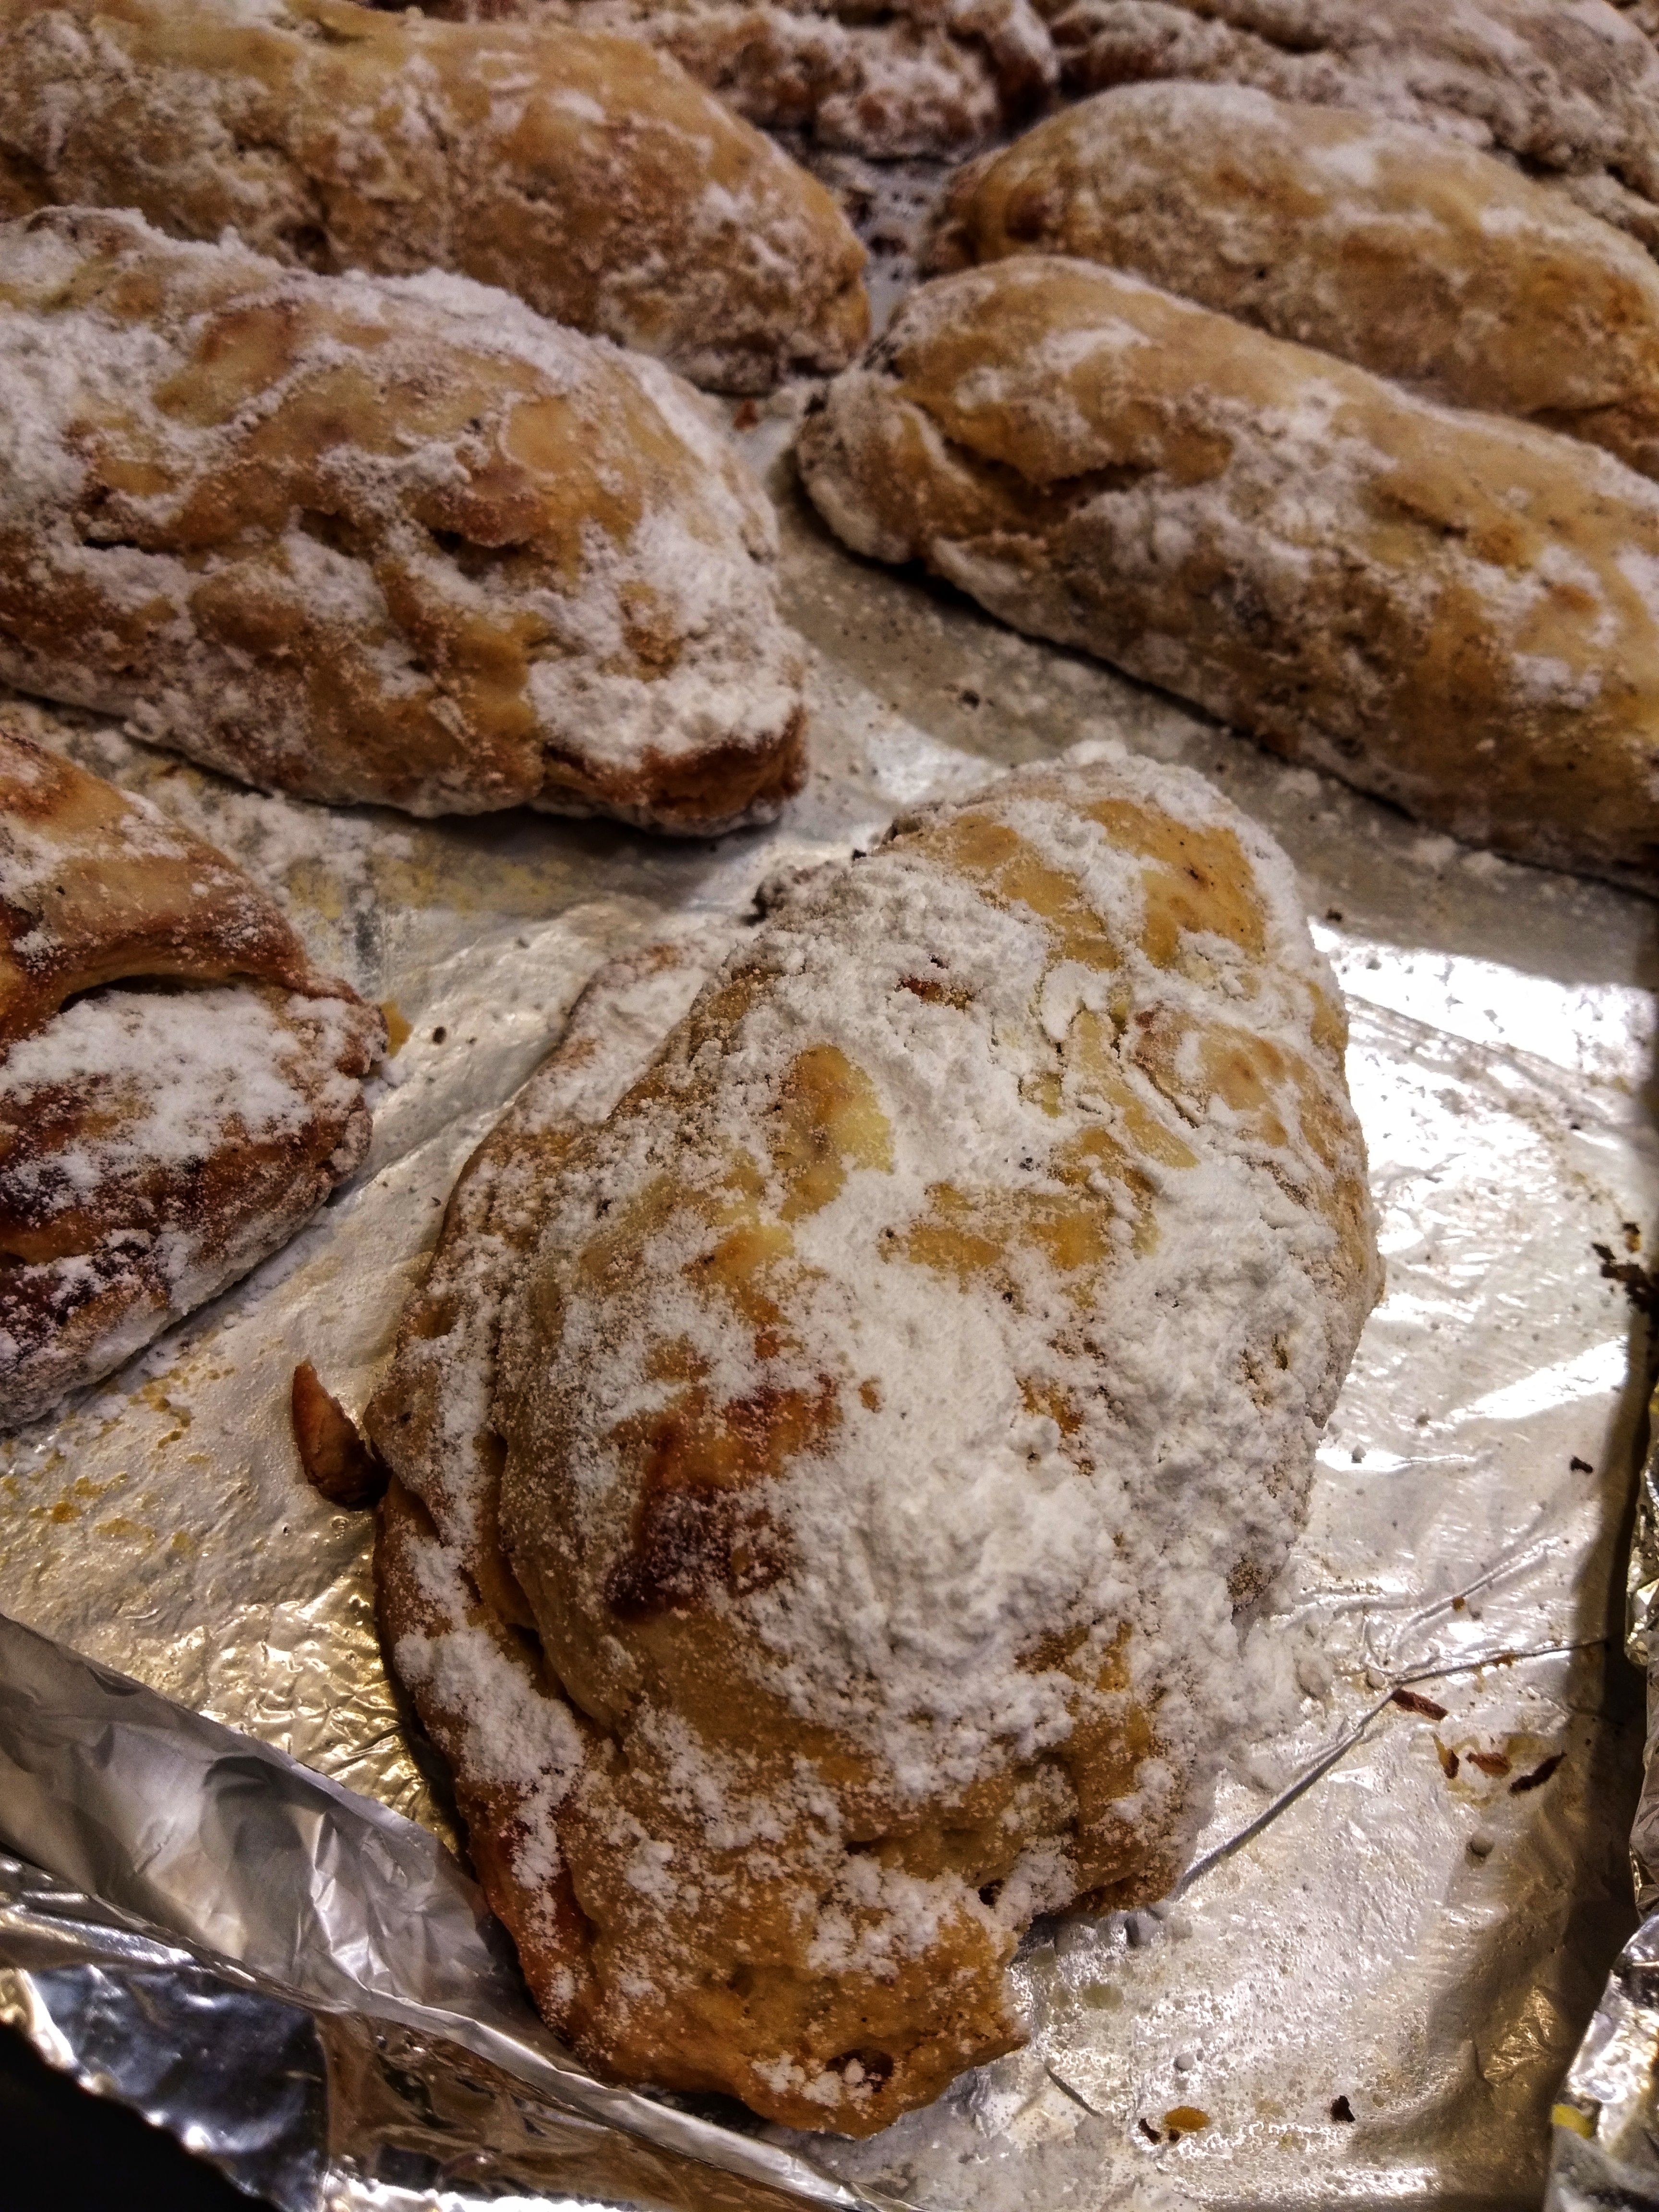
[{"left": 0, "top": 0, "right": 869, "bottom": 392}]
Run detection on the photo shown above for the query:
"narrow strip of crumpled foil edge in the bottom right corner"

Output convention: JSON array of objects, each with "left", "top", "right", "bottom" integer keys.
[{"left": 1544, "top": 1391, "right": 1659, "bottom": 2212}]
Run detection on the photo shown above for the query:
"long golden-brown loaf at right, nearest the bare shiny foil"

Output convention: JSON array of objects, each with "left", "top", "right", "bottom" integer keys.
[{"left": 798, "top": 254, "right": 1659, "bottom": 894}]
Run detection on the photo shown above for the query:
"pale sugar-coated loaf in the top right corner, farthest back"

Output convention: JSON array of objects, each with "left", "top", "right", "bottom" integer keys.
[{"left": 1040, "top": 0, "right": 1659, "bottom": 252}]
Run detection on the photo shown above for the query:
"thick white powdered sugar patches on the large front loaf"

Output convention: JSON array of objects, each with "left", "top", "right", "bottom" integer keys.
[{"left": 516, "top": 763, "right": 1371, "bottom": 1798}]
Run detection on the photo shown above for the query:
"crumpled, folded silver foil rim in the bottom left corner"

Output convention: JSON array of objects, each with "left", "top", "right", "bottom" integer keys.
[{"left": 0, "top": 1615, "right": 889, "bottom": 2212}]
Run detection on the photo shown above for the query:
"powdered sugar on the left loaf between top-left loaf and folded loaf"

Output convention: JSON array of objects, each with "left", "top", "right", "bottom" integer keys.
[{"left": 0, "top": 215, "right": 801, "bottom": 827}]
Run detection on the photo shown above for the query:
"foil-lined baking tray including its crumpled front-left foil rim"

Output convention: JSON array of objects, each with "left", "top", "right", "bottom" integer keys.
[{"left": 0, "top": 418, "right": 1659, "bottom": 2212}]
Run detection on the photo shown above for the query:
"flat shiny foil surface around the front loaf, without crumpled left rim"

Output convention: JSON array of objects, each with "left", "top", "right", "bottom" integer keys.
[{"left": 0, "top": 422, "right": 1659, "bottom": 2212}]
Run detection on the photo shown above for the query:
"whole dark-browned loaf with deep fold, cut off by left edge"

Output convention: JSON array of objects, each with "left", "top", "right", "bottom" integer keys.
[{"left": 0, "top": 710, "right": 385, "bottom": 1427}]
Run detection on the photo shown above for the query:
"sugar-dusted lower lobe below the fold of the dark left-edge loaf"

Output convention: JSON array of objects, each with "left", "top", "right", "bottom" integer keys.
[{"left": 0, "top": 985, "right": 383, "bottom": 1427}]
